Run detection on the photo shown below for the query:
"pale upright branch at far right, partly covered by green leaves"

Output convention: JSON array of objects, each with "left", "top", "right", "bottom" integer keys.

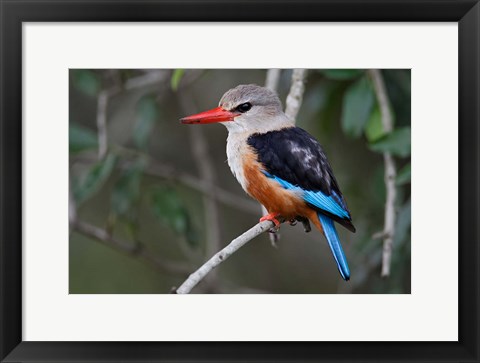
[{"left": 368, "top": 69, "right": 397, "bottom": 276}]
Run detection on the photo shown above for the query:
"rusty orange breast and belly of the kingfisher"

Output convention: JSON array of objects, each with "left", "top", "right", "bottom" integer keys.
[{"left": 243, "top": 150, "right": 313, "bottom": 219}]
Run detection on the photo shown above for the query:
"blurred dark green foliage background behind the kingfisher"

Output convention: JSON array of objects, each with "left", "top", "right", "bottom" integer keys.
[{"left": 69, "top": 69, "right": 411, "bottom": 294}]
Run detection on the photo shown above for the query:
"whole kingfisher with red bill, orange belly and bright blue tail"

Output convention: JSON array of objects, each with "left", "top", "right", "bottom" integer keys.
[{"left": 180, "top": 84, "right": 355, "bottom": 280}]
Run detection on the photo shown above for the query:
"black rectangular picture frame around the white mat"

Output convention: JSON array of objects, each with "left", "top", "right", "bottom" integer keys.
[{"left": 0, "top": 0, "right": 480, "bottom": 362}]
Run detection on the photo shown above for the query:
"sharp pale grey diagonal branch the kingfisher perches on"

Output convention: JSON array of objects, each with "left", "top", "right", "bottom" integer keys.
[{"left": 176, "top": 221, "right": 273, "bottom": 294}]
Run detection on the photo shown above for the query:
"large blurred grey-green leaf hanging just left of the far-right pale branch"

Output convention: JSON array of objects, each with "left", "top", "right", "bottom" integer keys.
[{"left": 342, "top": 77, "right": 374, "bottom": 138}]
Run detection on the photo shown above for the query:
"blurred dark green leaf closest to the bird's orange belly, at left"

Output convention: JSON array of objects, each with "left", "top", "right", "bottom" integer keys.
[{"left": 151, "top": 187, "right": 198, "bottom": 246}]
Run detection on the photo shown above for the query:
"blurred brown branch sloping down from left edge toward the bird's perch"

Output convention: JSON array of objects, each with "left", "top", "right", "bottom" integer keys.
[{"left": 70, "top": 220, "right": 190, "bottom": 275}]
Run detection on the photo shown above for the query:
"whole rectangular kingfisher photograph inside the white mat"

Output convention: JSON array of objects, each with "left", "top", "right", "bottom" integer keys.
[{"left": 69, "top": 68, "right": 411, "bottom": 294}]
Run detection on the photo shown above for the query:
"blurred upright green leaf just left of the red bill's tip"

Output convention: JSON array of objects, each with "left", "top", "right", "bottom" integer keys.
[{"left": 133, "top": 95, "right": 159, "bottom": 150}]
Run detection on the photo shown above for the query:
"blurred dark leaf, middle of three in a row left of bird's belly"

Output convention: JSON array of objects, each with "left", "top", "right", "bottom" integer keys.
[{"left": 111, "top": 159, "right": 146, "bottom": 216}]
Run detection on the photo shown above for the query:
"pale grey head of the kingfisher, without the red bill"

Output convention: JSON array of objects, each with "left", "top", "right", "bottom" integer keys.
[{"left": 219, "top": 84, "right": 293, "bottom": 132}]
